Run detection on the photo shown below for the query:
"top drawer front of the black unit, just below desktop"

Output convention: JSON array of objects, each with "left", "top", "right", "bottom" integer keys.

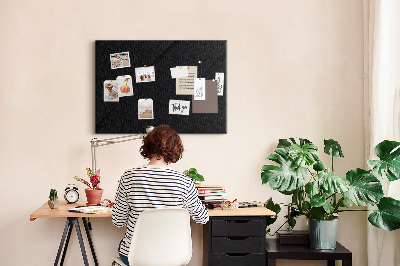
[{"left": 211, "top": 218, "right": 265, "bottom": 236}]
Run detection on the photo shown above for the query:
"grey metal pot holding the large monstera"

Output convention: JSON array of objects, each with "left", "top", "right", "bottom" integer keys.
[{"left": 308, "top": 219, "right": 339, "bottom": 249}]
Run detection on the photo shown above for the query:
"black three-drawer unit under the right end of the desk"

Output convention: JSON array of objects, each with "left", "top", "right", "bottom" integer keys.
[{"left": 203, "top": 216, "right": 266, "bottom": 266}]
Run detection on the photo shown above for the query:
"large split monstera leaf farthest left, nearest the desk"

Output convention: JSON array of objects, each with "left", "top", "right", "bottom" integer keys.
[{"left": 261, "top": 149, "right": 307, "bottom": 192}]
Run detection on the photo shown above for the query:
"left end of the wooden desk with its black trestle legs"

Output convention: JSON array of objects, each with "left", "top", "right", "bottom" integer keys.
[{"left": 30, "top": 200, "right": 111, "bottom": 266}]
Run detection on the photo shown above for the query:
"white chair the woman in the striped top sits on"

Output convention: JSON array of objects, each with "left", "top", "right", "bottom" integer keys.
[{"left": 113, "top": 208, "right": 192, "bottom": 266}]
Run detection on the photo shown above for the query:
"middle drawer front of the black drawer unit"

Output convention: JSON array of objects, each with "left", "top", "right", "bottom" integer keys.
[{"left": 211, "top": 237, "right": 265, "bottom": 253}]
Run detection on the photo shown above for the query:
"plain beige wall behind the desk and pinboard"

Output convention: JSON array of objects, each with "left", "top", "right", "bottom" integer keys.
[{"left": 0, "top": 0, "right": 366, "bottom": 265}]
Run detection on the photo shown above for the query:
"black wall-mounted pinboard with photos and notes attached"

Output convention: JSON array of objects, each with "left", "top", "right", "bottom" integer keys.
[{"left": 95, "top": 41, "right": 227, "bottom": 133}]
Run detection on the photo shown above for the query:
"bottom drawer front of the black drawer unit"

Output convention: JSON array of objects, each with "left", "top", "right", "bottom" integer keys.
[{"left": 210, "top": 253, "right": 266, "bottom": 266}]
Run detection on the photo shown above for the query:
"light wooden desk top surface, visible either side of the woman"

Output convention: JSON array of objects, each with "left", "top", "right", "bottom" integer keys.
[{"left": 30, "top": 200, "right": 275, "bottom": 221}]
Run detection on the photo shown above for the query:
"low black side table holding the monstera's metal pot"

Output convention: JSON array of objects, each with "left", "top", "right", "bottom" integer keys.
[{"left": 266, "top": 239, "right": 352, "bottom": 266}]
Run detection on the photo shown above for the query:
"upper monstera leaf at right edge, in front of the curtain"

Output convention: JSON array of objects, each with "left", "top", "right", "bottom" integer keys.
[{"left": 367, "top": 140, "right": 400, "bottom": 181}]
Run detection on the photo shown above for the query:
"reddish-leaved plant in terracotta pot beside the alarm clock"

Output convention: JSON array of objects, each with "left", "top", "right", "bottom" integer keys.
[{"left": 74, "top": 168, "right": 103, "bottom": 206}]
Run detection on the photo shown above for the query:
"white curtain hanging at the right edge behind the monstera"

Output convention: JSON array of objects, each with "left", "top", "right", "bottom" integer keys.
[{"left": 364, "top": 0, "right": 400, "bottom": 266}]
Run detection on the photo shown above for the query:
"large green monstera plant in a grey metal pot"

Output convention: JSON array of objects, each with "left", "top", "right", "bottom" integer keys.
[{"left": 261, "top": 138, "right": 400, "bottom": 249}]
